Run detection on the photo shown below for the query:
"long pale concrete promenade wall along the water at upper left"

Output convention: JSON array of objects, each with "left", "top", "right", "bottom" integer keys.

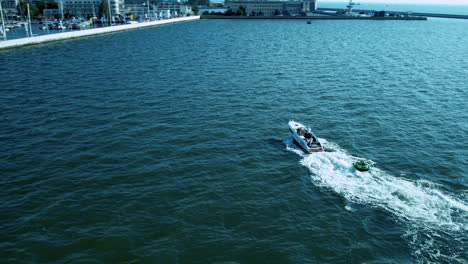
[{"left": 0, "top": 16, "right": 200, "bottom": 50}]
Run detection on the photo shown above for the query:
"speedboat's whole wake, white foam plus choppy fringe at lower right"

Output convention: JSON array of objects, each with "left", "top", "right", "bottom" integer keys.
[{"left": 285, "top": 137, "right": 468, "bottom": 263}]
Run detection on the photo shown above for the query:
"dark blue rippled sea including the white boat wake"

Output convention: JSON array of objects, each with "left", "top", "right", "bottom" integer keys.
[{"left": 0, "top": 9, "right": 468, "bottom": 264}]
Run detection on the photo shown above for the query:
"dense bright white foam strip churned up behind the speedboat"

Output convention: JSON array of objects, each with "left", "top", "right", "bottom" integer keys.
[{"left": 301, "top": 140, "right": 468, "bottom": 231}]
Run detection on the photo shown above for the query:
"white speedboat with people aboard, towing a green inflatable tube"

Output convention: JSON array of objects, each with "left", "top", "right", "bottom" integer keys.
[{"left": 288, "top": 120, "right": 325, "bottom": 153}]
